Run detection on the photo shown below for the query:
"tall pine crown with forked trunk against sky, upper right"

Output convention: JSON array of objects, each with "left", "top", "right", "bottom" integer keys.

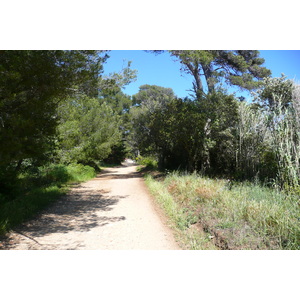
[{"left": 149, "top": 50, "right": 271, "bottom": 99}]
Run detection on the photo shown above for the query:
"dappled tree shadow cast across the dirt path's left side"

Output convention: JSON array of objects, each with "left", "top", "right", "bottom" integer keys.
[{"left": 0, "top": 186, "right": 127, "bottom": 250}]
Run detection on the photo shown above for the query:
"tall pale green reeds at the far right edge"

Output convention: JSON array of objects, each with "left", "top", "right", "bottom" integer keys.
[{"left": 236, "top": 76, "right": 300, "bottom": 187}]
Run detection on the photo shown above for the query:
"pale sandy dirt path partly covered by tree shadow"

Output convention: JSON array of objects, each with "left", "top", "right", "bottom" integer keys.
[{"left": 3, "top": 165, "right": 179, "bottom": 250}]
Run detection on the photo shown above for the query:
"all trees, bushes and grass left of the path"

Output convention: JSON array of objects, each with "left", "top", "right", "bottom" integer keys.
[{"left": 0, "top": 50, "right": 135, "bottom": 235}]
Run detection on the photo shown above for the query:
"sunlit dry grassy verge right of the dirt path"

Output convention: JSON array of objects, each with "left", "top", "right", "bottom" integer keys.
[{"left": 146, "top": 173, "right": 300, "bottom": 249}]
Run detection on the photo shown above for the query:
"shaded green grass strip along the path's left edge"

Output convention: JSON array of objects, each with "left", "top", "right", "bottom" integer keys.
[{"left": 0, "top": 164, "right": 96, "bottom": 235}]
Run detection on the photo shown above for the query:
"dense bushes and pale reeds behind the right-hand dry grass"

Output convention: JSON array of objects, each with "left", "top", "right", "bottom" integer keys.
[{"left": 131, "top": 77, "right": 300, "bottom": 190}]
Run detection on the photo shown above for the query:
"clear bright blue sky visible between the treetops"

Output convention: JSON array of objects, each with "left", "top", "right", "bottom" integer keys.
[{"left": 104, "top": 50, "right": 300, "bottom": 100}]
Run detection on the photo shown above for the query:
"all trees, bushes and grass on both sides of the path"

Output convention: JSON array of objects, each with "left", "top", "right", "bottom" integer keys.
[{"left": 0, "top": 50, "right": 300, "bottom": 249}]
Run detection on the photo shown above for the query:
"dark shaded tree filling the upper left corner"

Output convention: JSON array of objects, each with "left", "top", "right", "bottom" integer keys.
[{"left": 0, "top": 51, "right": 107, "bottom": 170}]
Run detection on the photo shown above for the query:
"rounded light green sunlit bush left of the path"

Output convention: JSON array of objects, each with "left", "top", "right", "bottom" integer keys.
[{"left": 58, "top": 96, "right": 121, "bottom": 163}]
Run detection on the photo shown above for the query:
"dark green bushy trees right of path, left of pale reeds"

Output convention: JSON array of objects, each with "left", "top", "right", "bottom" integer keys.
[{"left": 132, "top": 85, "right": 237, "bottom": 175}]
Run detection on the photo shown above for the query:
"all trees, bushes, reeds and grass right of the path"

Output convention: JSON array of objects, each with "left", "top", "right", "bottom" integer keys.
[{"left": 132, "top": 51, "right": 300, "bottom": 249}]
